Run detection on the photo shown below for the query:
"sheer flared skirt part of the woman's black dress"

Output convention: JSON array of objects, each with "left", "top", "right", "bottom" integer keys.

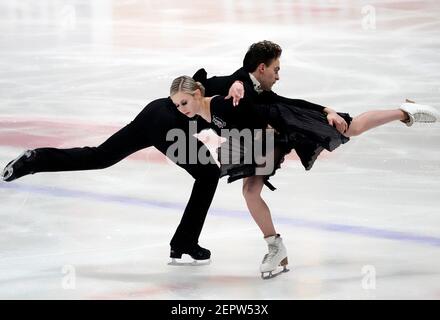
[{"left": 217, "top": 103, "right": 353, "bottom": 190}]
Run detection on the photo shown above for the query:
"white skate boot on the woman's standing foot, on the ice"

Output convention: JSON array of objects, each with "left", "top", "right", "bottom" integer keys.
[{"left": 260, "top": 234, "right": 289, "bottom": 279}]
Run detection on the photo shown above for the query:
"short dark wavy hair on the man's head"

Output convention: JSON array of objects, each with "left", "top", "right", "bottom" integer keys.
[{"left": 243, "top": 40, "right": 282, "bottom": 72}]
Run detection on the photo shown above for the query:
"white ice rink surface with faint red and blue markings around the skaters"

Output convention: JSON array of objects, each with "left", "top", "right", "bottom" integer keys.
[{"left": 0, "top": 0, "right": 440, "bottom": 299}]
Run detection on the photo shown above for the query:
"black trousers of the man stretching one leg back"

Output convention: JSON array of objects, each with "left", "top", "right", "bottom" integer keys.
[{"left": 28, "top": 99, "right": 220, "bottom": 250}]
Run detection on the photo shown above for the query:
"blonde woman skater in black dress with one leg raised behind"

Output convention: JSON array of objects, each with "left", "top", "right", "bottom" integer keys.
[{"left": 170, "top": 73, "right": 440, "bottom": 279}]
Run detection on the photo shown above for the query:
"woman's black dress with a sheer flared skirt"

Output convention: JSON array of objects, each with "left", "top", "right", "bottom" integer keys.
[{"left": 205, "top": 96, "right": 352, "bottom": 190}]
